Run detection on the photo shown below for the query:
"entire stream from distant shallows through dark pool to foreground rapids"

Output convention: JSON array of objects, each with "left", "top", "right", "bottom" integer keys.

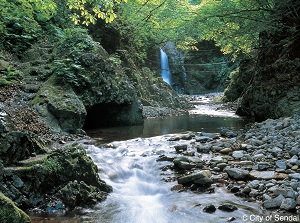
[{"left": 34, "top": 94, "right": 263, "bottom": 223}]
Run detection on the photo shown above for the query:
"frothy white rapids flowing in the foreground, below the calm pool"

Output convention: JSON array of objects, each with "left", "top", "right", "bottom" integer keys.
[{"left": 81, "top": 136, "right": 262, "bottom": 223}]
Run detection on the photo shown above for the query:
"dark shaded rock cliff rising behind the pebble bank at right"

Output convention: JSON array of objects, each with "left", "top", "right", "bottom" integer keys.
[{"left": 227, "top": 1, "right": 300, "bottom": 120}]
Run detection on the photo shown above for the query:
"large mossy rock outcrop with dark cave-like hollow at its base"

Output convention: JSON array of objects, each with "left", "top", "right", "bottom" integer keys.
[{"left": 27, "top": 38, "right": 143, "bottom": 133}]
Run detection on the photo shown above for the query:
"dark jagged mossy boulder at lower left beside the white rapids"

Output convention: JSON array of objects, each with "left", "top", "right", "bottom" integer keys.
[{"left": 0, "top": 144, "right": 112, "bottom": 211}]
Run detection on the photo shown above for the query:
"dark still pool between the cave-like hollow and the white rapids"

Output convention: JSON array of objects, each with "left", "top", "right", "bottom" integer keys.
[{"left": 87, "top": 114, "right": 250, "bottom": 142}]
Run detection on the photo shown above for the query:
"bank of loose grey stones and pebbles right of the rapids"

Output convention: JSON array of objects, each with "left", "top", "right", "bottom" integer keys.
[{"left": 157, "top": 116, "right": 300, "bottom": 214}]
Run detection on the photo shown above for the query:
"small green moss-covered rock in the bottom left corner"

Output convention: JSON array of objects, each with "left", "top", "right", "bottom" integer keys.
[{"left": 0, "top": 192, "right": 31, "bottom": 223}]
